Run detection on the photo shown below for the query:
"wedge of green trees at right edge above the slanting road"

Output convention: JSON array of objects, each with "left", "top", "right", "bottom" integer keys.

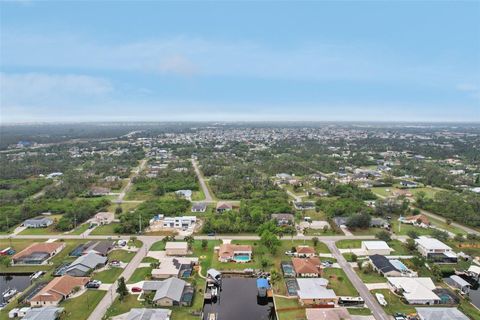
[{"left": 415, "top": 191, "right": 480, "bottom": 227}]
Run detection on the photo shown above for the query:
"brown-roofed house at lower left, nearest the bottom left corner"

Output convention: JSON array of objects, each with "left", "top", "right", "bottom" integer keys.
[{"left": 30, "top": 275, "right": 90, "bottom": 307}]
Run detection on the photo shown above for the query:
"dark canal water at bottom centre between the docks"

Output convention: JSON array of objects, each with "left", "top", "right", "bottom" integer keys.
[{"left": 203, "top": 278, "right": 275, "bottom": 320}]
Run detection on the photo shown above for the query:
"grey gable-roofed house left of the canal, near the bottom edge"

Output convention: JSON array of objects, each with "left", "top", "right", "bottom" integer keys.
[{"left": 143, "top": 278, "right": 192, "bottom": 307}]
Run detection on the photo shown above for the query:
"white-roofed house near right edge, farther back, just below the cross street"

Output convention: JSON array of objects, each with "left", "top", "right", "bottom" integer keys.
[{"left": 415, "top": 236, "right": 458, "bottom": 263}]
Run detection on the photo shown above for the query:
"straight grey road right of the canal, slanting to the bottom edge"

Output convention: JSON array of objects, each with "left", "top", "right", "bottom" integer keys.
[{"left": 323, "top": 240, "right": 392, "bottom": 320}]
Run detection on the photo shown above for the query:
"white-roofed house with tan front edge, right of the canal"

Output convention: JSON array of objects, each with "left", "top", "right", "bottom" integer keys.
[{"left": 297, "top": 278, "right": 337, "bottom": 306}]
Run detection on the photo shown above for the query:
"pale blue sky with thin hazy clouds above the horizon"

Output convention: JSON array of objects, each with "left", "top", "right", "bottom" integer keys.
[{"left": 0, "top": 0, "right": 480, "bottom": 123}]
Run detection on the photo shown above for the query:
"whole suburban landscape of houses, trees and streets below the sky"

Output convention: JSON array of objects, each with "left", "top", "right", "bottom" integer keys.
[{"left": 0, "top": 122, "right": 480, "bottom": 320}]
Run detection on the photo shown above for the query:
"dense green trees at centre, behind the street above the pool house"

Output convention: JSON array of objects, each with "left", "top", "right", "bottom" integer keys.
[{"left": 203, "top": 190, "right": 292, "bottom": 233}]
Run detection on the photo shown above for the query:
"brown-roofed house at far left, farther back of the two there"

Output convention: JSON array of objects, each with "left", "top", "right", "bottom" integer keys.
[{"left": 12, "top": 242, "right": 65, "bottom": 265}]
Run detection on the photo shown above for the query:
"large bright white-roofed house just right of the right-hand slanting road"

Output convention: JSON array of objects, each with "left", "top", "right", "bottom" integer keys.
[{"left": 387, "top": 277, "right": 441, "bottom": 305}]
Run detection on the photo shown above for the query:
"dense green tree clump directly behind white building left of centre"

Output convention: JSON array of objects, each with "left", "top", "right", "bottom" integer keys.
[{"left": 114, "top": 199, "right": 190, "bottom": 233}]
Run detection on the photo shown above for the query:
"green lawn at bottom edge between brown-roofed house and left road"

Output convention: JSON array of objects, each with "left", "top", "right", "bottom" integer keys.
[{"left": 60, "top": 290, "right": 106, "bottom": 320}]
